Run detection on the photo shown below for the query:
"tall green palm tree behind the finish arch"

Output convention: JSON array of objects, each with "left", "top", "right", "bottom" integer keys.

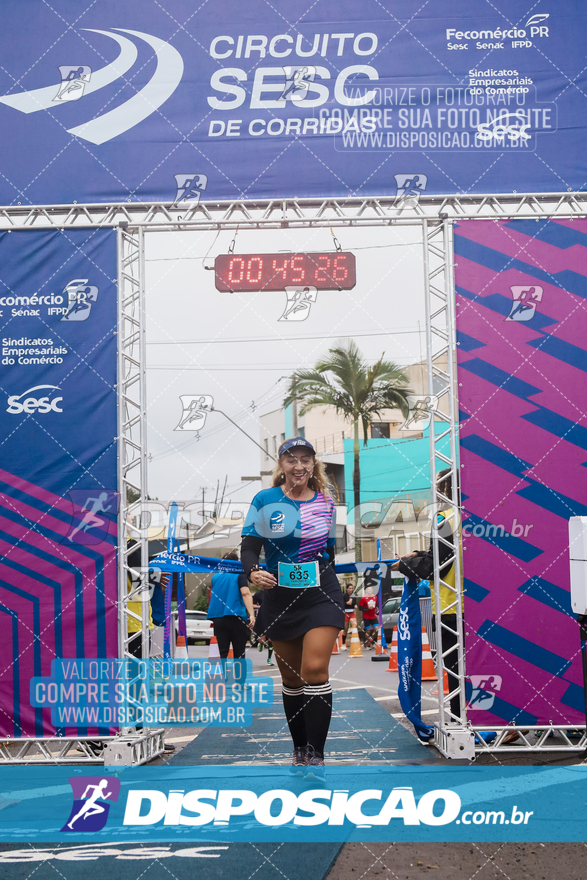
[{"left": 284, "top": 339, "right": 412, "bottom": 562}]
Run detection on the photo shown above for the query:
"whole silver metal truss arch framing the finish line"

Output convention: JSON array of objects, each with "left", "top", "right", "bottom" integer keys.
[{"left": 0, "top": 192, "right": 587, "bottom": 765}]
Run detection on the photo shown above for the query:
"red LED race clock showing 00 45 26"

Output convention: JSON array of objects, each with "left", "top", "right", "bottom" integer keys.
[{"left": 214, "top": 251, "right": 357, "bottom": 293}]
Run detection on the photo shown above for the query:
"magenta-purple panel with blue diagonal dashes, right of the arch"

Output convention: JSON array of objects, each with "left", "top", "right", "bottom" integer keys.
[{"left": 455, "top": 220, "right": 587, "bottom": 726}]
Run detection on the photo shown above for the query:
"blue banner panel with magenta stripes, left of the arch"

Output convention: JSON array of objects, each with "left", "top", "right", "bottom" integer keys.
[{"left": 0, "top": 229, "right": 118, "bottom": 737}]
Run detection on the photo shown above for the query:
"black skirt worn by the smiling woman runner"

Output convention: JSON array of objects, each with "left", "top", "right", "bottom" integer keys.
[{"left": 254, "top": 565, "right": 344, "bottom": 642}]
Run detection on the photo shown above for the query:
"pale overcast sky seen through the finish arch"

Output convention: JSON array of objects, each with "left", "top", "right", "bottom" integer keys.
[{"left": 145, "top": 226, "right": 425, "bottom": 506}]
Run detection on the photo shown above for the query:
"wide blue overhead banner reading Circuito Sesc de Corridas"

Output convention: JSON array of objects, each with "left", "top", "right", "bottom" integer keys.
[{"left": 0, "top": 0, "right": 587, "bottom": 205}]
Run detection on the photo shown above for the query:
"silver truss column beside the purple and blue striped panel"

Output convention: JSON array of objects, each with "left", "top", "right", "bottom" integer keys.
[{"left": 423, "top": 219, "right": 474, "bottom": 757}]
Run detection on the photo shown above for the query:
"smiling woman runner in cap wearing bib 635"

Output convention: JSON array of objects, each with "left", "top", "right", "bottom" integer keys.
[{"left": 241, "top": 437, "right": 344, "bottom": 778}]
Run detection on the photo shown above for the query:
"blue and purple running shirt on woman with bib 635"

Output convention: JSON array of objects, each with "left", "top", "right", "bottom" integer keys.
[{"left": 242, "top": 486, "right": 336, "bottom": 572}]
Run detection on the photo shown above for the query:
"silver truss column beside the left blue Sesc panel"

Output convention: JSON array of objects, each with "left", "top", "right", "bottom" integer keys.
[{"left": 117, "top": 224, "right": 149, "bottom": 657}]
